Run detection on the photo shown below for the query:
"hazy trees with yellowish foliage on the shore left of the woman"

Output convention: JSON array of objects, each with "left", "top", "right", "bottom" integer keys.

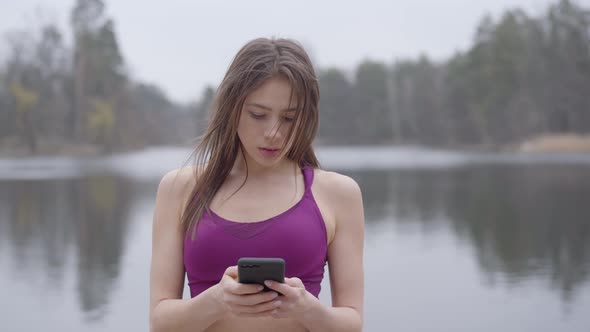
[{"left": 0, "top": 0, "right": 194, "bottom": 153}]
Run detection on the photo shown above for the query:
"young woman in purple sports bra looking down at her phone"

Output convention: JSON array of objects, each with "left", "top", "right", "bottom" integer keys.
[{"left": 150, "top": 38, "right": 364, "bottom": 332}]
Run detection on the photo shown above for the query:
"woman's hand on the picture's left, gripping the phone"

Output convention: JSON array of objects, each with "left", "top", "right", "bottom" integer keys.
[{"left": 216, "top": 266, "right": 280, "bottom": 317}]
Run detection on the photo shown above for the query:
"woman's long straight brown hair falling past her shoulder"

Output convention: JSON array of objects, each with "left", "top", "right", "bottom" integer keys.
[{"left": 181, "top": 38, "right": 320, "bottom": 239}]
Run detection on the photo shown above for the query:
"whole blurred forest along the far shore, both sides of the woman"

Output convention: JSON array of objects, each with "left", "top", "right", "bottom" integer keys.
[{"left": 0, "top": 0, "right": 590, "bottom": 154}]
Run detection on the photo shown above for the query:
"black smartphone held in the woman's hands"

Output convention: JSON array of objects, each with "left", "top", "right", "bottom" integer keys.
[{"left": 238, "top": 257, "right": 285, "bottom": 291}]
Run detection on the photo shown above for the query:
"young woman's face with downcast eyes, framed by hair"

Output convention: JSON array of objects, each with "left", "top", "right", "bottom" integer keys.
[{"left": 238, "top": 77, "right": 297, "bottom": 167}]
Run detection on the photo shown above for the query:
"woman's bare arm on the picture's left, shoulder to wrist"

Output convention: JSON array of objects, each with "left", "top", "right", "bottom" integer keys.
[{"left": 150, "top": 171, "right": 223, "bottom": 332}]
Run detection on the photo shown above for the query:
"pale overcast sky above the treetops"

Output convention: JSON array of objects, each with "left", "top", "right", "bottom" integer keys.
[{"left": 0, "top": 0, "right": 590, "bottom": 102}]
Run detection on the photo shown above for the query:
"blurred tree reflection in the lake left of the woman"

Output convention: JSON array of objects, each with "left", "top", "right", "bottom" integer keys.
[{"left": 0, "top": 175, "right": 132, "bottom": 319}]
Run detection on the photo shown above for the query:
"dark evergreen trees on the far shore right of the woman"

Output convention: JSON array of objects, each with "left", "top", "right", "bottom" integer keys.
[{"left": 320, "top": 0, "right": 590, "bottom": 146}]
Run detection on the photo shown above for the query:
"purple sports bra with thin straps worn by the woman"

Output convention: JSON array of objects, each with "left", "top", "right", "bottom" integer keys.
[{"left": 184, "top": 167, "right": 328, "bottom": 297}]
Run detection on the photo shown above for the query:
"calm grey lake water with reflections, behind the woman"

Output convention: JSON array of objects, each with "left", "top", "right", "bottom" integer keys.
[{"left": 0, "top": 147, "right": 590, "bottom": 332}]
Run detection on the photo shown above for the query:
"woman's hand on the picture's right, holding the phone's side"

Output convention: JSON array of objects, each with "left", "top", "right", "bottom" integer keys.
[{"left": 264, "top": 278, "right": 312, "bottom": 320}]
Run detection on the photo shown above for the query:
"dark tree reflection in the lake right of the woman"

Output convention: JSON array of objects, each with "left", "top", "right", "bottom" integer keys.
[{"left": 349, "top": 165, "right": 590, "bottom": 302}]
